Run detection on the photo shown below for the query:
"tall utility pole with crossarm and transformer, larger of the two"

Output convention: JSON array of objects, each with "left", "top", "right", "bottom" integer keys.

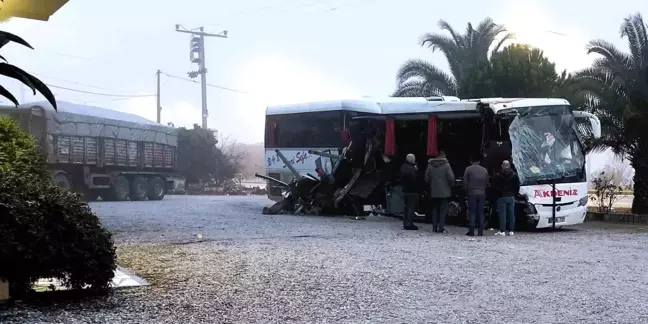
[{"left": 176, "top": 25, "right": 227, "bottom": 129}]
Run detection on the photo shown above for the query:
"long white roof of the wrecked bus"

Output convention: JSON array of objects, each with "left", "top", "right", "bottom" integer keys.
[{"left": 266, "top": 97, "right": 569, "bottom": 115}]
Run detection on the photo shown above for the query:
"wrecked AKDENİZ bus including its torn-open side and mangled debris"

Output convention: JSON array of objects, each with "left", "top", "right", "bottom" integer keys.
[{"left": 266, "top": 97, "right": 601, "bottom": 228}]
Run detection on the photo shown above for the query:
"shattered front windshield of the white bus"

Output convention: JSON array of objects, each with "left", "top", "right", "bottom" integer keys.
[{"left": 509, "top": 106, "right": 586, "bottom": 185}]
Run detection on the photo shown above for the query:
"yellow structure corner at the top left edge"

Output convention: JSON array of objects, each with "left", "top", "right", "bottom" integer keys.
[{"left": 0, "top": 0, "right": 68, "bottom": 21}]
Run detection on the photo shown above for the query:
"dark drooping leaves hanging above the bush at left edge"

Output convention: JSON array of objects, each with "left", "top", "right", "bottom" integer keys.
[{"left": 0, "top": 31, "right": 56, "bottom": 109}]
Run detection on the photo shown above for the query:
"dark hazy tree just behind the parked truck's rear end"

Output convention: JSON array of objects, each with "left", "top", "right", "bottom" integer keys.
[{"left": 178, "top": 125, "right": 236, "bottom": 183}]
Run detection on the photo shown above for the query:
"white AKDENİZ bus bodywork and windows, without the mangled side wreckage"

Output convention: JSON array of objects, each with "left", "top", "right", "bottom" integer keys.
[{"left": 266, "top": 97, "right": 601, "bottom": 228}]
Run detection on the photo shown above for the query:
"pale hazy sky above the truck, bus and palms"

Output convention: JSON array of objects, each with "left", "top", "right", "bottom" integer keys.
[{"left": 2, "top": 0, "right": 648, "bottom": 146}]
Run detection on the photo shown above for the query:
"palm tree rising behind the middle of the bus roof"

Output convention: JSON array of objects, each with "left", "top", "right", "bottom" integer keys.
[{"left": 393, "top": 18, "right": 512, "bottom": 97}]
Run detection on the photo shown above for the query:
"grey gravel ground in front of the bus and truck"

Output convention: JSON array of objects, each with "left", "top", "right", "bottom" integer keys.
[{"left": 0, "top": 196, "right": 648, "bottom": 324}]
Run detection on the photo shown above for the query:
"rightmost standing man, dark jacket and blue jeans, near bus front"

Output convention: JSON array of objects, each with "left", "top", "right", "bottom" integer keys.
[{"left": 491, "top": 160, "right": 520, "bottom": 236}]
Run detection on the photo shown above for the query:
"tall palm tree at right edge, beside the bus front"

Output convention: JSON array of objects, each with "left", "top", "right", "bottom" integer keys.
[{"left": 574, "top": 13, "right": 648, "bottom": 214}]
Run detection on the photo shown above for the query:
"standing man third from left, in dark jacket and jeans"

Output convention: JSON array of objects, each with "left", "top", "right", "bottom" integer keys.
[{"left": 463, "top": 158, "right": 489, "bottom": 236}]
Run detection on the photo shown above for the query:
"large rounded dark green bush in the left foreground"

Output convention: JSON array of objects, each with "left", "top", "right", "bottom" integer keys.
[{"left": 0, "top": 118, "right": 116, "bottom": 298}]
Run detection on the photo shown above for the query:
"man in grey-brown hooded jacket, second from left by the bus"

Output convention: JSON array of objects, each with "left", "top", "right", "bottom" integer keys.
[{"left": 425, "top": 151, "right": 454, "bottom": 233}]
